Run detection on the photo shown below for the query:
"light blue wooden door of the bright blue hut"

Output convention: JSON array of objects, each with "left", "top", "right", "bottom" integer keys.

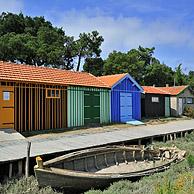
[{"left": 120, "top": 92, "right": 133, "bottom": 123}]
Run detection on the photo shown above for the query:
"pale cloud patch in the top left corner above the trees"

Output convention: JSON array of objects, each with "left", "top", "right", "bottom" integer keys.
[{"left": 0, "top": 0, "right": 23, "bottom": 13}]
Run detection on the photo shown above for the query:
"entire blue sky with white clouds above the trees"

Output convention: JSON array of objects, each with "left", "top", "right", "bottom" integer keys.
[{"left": 0, "top": 0, "right": 194, "bottom": 72}]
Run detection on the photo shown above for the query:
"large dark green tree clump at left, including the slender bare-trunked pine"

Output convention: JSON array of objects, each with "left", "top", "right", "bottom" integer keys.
[{"left": 0, "top": 13, "right": 104, "bottom": 71}]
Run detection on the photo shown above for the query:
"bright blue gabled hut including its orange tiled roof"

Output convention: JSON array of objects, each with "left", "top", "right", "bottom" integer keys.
[{"left": 99, "top": 73, "right": 143, "bottom": 123}]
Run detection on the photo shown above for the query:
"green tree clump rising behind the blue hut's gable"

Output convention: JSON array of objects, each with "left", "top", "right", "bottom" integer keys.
[{"left": 104, "top": 46, "right": 174, "bottom": 86}]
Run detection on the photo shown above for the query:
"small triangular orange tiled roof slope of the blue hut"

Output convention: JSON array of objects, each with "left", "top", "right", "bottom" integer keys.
[{"left": 98, "top": 73, "right": 128, "bottom": 87}]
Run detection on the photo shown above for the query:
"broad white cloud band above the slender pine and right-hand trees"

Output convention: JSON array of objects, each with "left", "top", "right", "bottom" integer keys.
[{"left": 51, "top": 10, "right": 194, "bottom": 57}]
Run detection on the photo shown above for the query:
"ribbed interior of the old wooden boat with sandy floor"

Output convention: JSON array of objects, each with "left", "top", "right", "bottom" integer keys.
[{"left": 44, "top": 146, "right": 176, "bottom": 174}]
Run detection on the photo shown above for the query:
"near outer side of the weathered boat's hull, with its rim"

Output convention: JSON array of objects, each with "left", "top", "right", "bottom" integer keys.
[{"left": 35, "top": 160, "right": 174, "bottom": 191}]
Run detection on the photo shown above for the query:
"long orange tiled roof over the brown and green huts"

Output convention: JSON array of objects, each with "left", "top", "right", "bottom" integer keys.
[{"left": 0, "top": 61, "right": 108, "bottom": 88}]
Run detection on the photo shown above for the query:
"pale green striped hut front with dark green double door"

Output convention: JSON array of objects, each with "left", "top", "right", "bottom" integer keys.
[{"left": 67, "top": 86, "right": 110, "bottom": 127}]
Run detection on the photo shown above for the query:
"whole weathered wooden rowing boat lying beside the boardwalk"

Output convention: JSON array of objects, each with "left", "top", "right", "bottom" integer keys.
[{"left": 34, "top": 146, "right": 185, "bottom": 191}]
